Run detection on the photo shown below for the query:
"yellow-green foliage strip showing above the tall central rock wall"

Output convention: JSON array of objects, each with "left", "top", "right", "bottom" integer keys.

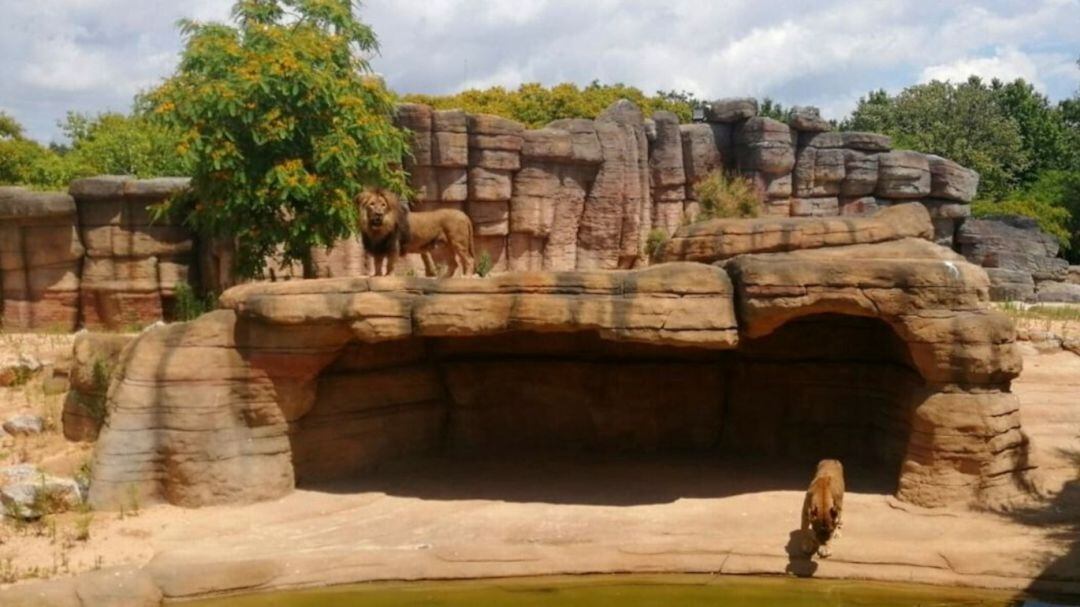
[{"left": 404, "top": 81, "right": 699, "bottom": 129}]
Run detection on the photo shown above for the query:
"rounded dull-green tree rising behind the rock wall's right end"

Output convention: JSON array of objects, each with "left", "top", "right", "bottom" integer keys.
[{"left": 842, "top": 77, "right": 1031, "bottom": 200}]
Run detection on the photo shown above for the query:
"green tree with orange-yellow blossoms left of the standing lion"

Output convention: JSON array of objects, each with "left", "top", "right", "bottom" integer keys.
[{"left": 146, "top": 0, "right": 407, "bottom": 276}]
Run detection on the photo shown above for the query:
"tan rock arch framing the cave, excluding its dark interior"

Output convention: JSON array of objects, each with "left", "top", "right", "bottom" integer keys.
[{"left": 92, "top": 204, "right": 1030, "bottom": 505}]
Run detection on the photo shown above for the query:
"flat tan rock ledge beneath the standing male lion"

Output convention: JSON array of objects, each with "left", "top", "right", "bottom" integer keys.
[{"left": 221, "top": 262, "right": 738, "bottom": 349}]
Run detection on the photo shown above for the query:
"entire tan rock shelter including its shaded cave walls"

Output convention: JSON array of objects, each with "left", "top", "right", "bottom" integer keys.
[{"left": 91, "top": 204, "right": 1030, "bottom": 507}]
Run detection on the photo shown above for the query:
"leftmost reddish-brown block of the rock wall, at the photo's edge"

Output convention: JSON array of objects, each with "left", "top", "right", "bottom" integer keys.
[{"left": 0, "top": 187, "right": 83, "bottom": 332}]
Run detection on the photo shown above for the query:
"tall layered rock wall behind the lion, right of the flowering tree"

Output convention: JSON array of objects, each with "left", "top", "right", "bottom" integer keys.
[{"left": 399, "top": 99, "right": 978, "bottom": 271}]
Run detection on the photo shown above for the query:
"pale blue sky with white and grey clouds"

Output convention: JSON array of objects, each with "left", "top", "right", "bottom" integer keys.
[{"left": 0, "top": 0, "right": 1080, "bottom": 141}]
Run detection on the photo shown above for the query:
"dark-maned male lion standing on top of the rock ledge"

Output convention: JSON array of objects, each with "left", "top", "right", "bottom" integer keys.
[{"left": 355, "top": 189, "right": 475, "bottom": 276}]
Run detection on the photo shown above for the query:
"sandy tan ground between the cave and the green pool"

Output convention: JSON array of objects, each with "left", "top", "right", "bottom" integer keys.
[{"left": 0, "top": 330, "right": 1080, "bottom": 597}]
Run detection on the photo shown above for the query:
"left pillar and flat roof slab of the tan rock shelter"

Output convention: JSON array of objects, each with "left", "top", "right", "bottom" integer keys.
[{"left": 92, "top": 265, "right": 738, "bottom": 505}]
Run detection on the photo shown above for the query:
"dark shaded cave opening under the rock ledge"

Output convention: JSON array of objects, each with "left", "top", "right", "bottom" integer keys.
[{"left": 291, "top": 314, "right": 922, "bottom": 499}]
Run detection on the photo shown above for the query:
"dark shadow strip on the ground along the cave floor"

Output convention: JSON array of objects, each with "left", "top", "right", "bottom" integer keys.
[{"left": 300, "top": 455, "right": 895, "bottom": 505}]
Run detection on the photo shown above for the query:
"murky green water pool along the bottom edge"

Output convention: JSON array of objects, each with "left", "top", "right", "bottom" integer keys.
[{"left": 186, "top": 576, "right": 1080, "bottom": 607}]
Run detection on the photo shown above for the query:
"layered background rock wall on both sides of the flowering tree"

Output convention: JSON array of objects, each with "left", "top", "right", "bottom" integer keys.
[{"left": 0, "top": 99, "right": 1080, "bottom": 329}]
